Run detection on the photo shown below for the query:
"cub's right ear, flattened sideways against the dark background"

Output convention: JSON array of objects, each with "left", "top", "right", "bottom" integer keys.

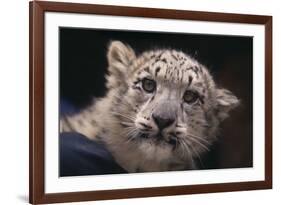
[{"left": 216, "top": 89, "right": 240, "bottom": 121}]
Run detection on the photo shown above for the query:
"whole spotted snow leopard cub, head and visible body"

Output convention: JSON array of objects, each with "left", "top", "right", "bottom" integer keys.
[{"left": 60, "top": 41, "right": 239, "bottom": 172}]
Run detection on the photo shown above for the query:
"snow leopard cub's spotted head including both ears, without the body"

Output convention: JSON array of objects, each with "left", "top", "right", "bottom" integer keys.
[{"left": 107, "top": 41, "right": 239, "bottom": 166}]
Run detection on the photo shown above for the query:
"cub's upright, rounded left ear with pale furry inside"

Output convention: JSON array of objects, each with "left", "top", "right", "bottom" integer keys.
[{"left": 107, "top": 41, "right": 136, "bottom": 81}]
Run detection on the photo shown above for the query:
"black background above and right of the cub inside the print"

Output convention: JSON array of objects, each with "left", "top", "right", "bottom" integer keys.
[{"left": 59, "top": 28, "right": 253, "bottom": 169}]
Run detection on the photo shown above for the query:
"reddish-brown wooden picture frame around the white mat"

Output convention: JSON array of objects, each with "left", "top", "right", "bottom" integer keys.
[{"left": 29, "top": 1, "right": 272, "bottom": 204}]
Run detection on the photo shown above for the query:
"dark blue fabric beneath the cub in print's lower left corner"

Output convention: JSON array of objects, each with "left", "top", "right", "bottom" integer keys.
[{"left": 59, "top": 133, "right": 127, "bottom": 176}]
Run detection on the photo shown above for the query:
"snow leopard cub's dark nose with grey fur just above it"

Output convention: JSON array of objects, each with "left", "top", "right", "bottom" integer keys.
[{"left": 152, "top": 101, "right": 177, "bottom": 130}]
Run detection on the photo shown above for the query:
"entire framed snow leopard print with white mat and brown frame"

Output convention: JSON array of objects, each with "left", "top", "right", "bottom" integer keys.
[{"left": 30, "top": 1, "right": 272, "bottom": 204}]
